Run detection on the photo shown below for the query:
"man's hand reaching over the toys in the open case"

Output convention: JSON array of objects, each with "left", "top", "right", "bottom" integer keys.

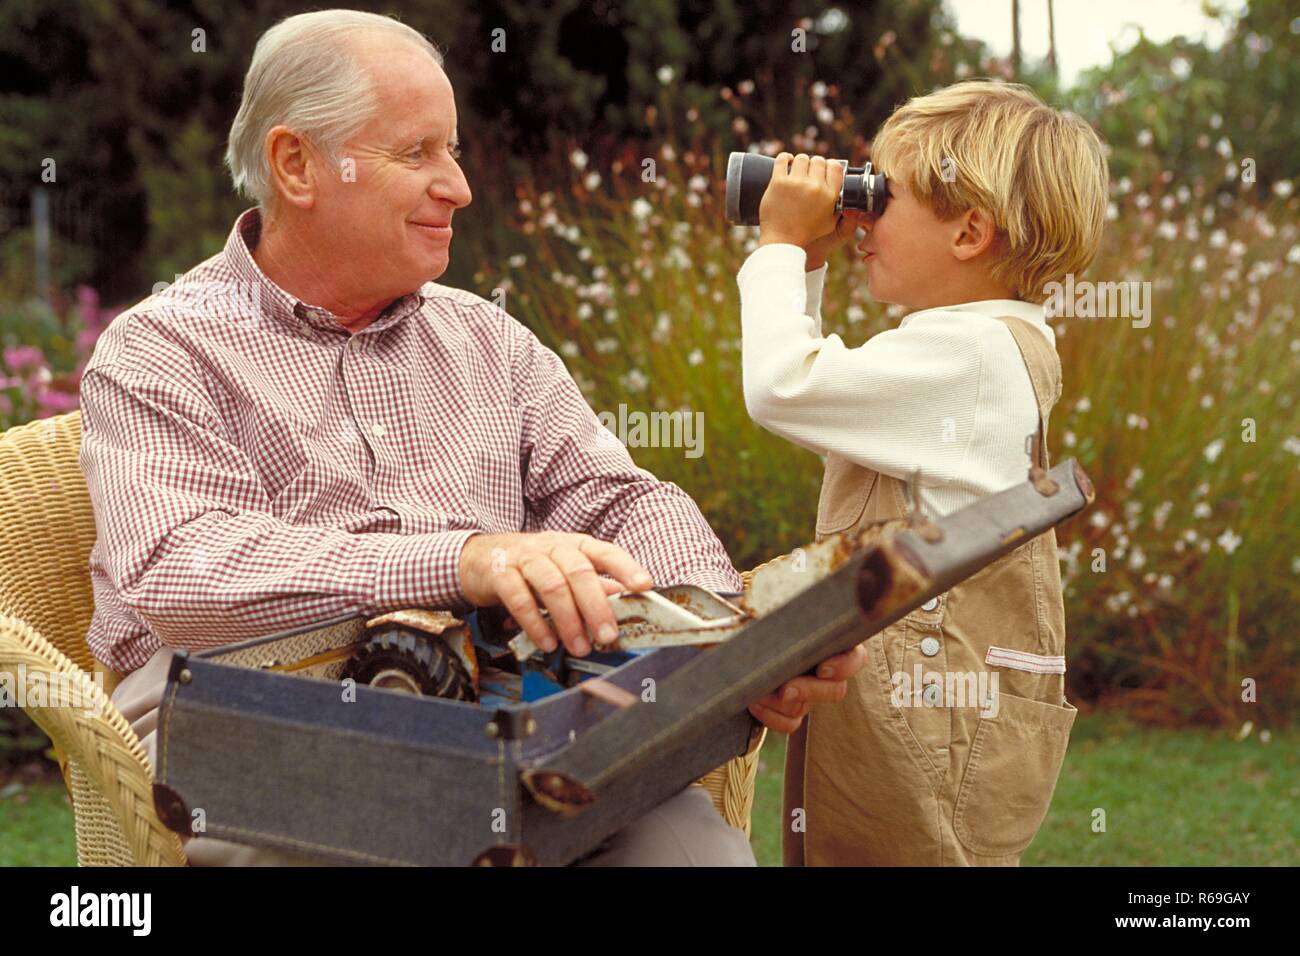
[{"left": 460, "top": 531, "right": 654, "bottom": 657}]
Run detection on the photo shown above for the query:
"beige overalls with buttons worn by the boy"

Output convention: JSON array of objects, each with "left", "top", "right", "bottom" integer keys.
[{"left": 783, "top": 316, "right": 1078, "bottom": 866}]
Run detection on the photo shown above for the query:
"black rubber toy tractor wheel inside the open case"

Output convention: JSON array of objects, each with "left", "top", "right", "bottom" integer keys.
[{"left": 343, "top": 627, "right": 477, "bottom": 701}]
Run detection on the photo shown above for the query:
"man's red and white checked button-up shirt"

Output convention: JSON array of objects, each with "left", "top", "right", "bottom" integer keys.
[{"left": 81, "top": 209, "right": 741, "bottom": 672}]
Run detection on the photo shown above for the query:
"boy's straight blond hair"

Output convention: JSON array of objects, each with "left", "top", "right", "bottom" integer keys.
[{"left": 871, "top": 79, "right": 1109, "bottom": 303}]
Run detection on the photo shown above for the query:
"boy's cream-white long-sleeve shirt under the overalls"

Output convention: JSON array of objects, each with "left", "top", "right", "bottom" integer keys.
[{"left": 737, "top": 243, "right": 1056, "bottom": 516}]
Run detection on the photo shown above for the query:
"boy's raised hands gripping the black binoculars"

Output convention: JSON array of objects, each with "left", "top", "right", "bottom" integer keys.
[{"left": 758, "top": 152, "right": 863, "bottom": 272}]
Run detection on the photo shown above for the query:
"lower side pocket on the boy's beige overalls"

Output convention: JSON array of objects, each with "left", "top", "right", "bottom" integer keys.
[{"left": 953, "top": 693, "right": 1079, "bottom": 856}]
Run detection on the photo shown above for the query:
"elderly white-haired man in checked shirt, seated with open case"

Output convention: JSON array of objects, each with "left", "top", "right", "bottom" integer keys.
[{"left": 82, "top": 10, "right": 862, "bottom": 865}]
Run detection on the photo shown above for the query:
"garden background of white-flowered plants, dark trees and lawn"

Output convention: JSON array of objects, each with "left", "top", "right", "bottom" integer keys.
[{"left": 0, "top": 0, "right": 1300, "bottom": 864}]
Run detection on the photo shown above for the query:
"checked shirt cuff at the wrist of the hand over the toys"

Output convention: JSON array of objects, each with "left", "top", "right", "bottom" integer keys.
[{"left": 374, "top": 529, "right": 478, "bottom": 614}]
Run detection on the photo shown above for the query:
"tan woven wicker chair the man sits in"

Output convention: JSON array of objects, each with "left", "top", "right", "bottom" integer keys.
[{"left": 0, "top": 412, "right": 761, "bottom": 866}]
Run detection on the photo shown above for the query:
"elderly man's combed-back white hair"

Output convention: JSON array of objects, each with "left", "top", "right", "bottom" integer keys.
[{"left": 226, "top": 10, "right": 442, "bottom": 209}]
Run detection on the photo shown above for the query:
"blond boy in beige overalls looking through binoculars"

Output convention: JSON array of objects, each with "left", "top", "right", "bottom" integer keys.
[{"left": 737, "top": 81, "right": 1108, "bottom": 866}]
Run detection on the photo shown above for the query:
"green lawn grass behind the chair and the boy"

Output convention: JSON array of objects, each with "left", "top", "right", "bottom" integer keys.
[{"left": 0, "top": 715, "right": 1300, "bottom": 866}]
